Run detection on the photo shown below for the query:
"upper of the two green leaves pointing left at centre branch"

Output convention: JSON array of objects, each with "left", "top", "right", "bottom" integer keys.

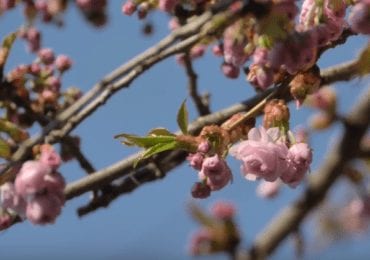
[{"left": 115, "top": 134, "right": 176, "bottom": 148}]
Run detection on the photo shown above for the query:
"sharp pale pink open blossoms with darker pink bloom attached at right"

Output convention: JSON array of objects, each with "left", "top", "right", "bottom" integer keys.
[{"left": 230, "top": 127, "right": 312, "bottom": 188}]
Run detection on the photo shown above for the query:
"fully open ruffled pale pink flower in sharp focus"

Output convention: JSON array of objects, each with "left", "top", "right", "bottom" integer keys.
[{"left": 230, "top": 127, "right": 288, "bottom": 181}]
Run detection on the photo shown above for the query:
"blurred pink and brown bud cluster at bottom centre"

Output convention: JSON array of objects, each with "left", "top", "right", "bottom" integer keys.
[{"left": 189, "top": 202, "right": 240, "bottom": 255}]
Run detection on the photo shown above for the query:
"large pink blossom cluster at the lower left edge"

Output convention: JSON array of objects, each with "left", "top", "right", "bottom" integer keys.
[{"left": 0, "top": 144, "right": 65, "bottom": 228}]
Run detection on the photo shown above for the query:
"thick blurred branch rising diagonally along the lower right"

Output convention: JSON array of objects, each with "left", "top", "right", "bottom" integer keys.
[{"left": 238, "top": 88, "right": 370, "bottom": 259}]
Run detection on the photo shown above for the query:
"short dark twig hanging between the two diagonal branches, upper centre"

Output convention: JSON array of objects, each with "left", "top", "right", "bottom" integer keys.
[{"left": 184, "top": 52, "right": 211, "bottom": 116}]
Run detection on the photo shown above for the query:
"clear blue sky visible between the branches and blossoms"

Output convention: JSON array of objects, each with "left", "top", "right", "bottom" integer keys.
[{"left": 0, "top": 1, "right": 370, "bottom": 259}]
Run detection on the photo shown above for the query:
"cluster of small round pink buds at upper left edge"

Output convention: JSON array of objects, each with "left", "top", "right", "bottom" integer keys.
[{"left": 6, "top": 48, "right": 81, "bottom": 127}]
